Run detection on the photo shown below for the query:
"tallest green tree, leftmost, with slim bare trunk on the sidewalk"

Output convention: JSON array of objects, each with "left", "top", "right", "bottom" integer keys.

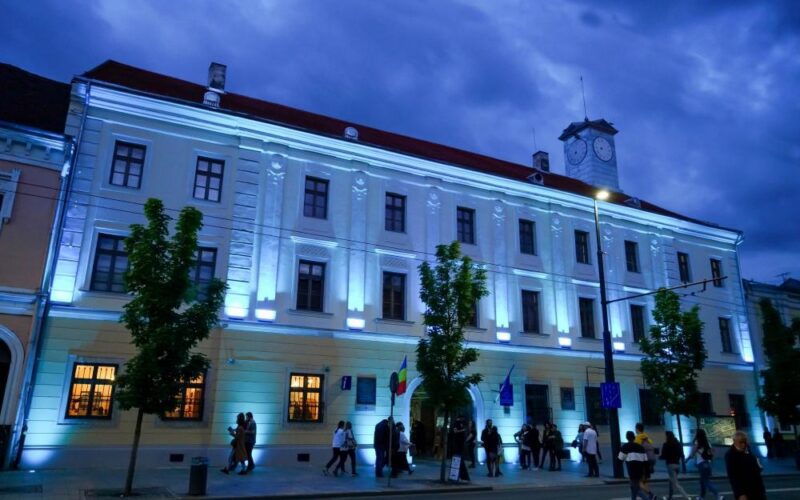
[{"left": 116, "top": 198, "right": 226, "bottom": 496}]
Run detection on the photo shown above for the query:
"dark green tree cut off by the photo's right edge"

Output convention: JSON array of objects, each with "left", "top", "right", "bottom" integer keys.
[{"left": 758, "top": 299, "right": 800, "bottom": 425}]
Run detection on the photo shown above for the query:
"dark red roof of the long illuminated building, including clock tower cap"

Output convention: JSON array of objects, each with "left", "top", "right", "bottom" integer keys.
[{"left": 82, "top": 60, "right": 732, "bottom": 232}]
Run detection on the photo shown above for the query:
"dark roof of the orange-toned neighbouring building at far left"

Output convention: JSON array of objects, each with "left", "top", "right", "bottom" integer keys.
[{"left": 0, "top": 63, "right": 70, "bottom": 134}]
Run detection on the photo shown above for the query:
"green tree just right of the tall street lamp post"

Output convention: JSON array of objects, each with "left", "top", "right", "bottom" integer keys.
[{"left": 639, "top": 289, "right": 708, "bottom": 458}]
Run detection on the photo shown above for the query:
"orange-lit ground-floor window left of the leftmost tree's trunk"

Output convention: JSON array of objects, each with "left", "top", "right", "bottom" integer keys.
[{"left": 66, "top": 363, "right": 117, "bottom": 420}]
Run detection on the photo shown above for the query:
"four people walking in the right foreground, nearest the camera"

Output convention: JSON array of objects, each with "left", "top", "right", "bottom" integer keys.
[{"left": 618, "top": 423, "right": 766, "bottom": 500}]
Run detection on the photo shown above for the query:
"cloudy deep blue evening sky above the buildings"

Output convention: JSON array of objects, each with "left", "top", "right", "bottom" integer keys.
[{"left": 0, "top": 0, "right": 800, "bottom": 283}]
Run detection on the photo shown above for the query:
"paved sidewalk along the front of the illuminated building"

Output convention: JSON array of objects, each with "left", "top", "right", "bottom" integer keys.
[{"left": 0, "top": 459, "right": 799, "bottom": 500}]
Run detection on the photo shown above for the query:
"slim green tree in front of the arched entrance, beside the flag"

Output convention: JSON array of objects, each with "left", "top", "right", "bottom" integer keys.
[{"left": 417, "top": 241, "right": 488, "bottom": 482}]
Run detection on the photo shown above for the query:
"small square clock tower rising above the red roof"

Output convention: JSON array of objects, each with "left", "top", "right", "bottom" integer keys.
[{"left": 558, "top": 118, "right": 620, "bottom": 191}]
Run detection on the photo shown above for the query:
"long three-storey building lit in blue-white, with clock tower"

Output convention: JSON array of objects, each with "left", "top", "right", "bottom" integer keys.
[{"left": 10, "top": 61, "right": 761, "bottom": 467}]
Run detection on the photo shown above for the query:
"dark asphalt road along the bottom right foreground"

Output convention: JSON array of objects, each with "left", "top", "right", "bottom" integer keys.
[{"left": 360, "top": 476, "right": 800, "bottom": 500}]
